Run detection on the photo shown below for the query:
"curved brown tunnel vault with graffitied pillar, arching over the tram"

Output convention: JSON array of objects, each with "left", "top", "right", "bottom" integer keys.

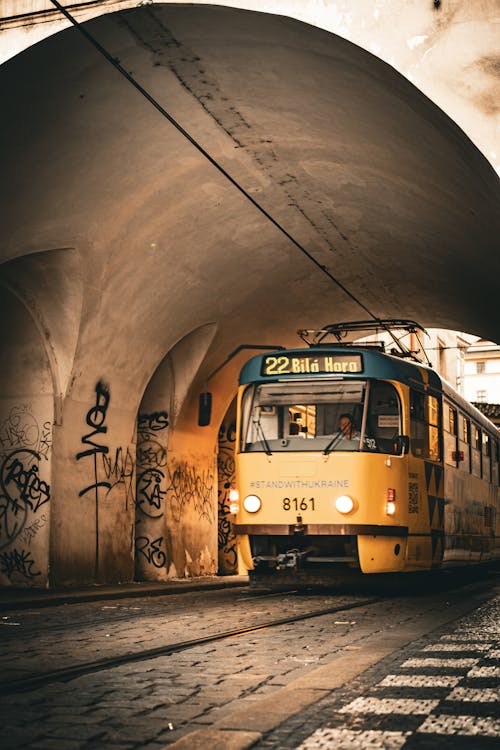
[{"left": 0, "top": 6, "right": 500, "bottom": 582}]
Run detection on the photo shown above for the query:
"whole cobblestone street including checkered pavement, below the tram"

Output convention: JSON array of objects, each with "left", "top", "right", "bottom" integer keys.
[{"left": 1, "top": 581, "right": 500, "bottom": 750}]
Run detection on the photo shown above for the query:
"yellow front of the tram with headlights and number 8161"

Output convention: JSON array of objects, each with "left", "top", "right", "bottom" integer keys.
[{"left": 233, "top": 348, "right": 409, "bottom": 583}]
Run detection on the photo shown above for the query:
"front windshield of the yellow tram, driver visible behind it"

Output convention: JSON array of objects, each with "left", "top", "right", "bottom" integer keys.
[{"left": 241, "top": 380, "right": 401, "bottom": 453}]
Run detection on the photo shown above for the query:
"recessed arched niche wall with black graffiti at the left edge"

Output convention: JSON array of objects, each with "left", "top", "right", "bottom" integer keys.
[{"left": 0, "top": 287, "right": 54, "bottom": 587}]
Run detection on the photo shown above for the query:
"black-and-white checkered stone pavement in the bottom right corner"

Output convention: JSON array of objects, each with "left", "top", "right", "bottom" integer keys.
[{"left": 254, "top": 596, "right": 500, "bottom": 750}]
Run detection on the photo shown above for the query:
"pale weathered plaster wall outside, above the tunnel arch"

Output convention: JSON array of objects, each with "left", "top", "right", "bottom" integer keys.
[{"left": 0, "top": 0, "right": 500, "bottom": 171}]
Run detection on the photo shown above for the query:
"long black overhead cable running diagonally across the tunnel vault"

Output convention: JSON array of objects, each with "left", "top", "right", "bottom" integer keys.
[{"left": 50, "top": 0, "right": 402, "bottom": 348}]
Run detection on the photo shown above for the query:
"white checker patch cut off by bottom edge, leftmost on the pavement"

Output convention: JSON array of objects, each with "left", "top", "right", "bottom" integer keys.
[{"left": 297, "top": 728, "right": 410, "bottom": 750}]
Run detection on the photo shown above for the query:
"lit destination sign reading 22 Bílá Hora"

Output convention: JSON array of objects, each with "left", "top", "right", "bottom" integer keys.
[{"left": 262, "top": 352, "right": 363, "bottom": 375}]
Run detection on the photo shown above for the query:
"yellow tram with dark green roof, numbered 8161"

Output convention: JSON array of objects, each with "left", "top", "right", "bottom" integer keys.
[{"left": 233, "top": 324, "right": 500, "bottom": 583}]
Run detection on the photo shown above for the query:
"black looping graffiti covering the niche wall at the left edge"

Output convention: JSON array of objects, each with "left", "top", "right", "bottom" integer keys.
[{"left": 0, "top": 404, "right": 52, "bottom": 560}]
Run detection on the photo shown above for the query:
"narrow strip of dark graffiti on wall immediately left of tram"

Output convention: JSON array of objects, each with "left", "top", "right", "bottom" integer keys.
[{"left": 217, "top": 420, "right": 237, "bottom": 575}]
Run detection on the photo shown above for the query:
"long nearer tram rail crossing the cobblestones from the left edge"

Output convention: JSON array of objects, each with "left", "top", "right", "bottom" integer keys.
[{"left": 0, "top": 596, "right": 383, "bottom": 695}]
